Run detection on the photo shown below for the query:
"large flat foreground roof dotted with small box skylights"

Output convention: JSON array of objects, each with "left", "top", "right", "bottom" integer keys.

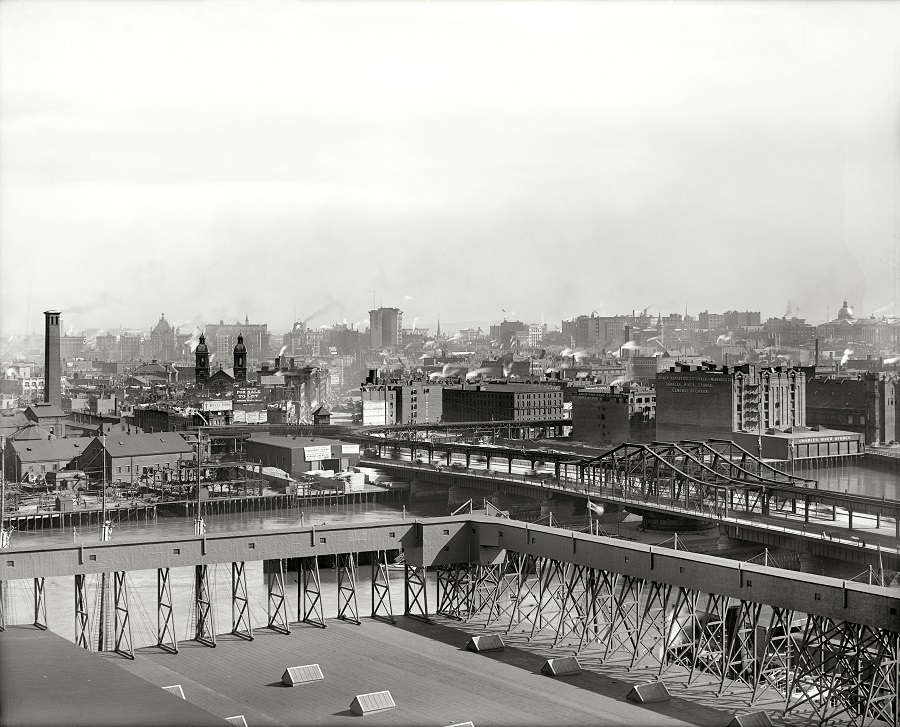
[{"left": 108, "top": 617, "right": 746, "bottom": 727}]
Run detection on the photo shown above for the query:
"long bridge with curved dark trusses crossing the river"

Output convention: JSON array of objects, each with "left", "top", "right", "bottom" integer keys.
[{"left": 362, "top": 440, "right": 900, "bottom": 570}]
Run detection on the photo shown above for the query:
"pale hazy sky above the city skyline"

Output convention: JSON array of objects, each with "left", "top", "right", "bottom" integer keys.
[{"left": 0, "top": 0, "right": 900, "bottom": 335}]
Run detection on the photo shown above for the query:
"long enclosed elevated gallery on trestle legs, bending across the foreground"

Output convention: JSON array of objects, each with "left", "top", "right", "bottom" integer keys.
[{"left": 0, "top": 515, "right": 900, "bottom": 726}]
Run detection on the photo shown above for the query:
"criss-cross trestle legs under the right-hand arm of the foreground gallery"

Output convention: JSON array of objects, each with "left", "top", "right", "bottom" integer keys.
[{"left": 436, "top": 551, "right": 900, "bottom": 726}]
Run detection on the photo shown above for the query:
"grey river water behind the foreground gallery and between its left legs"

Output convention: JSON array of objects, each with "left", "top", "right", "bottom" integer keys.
[{"left": 6, "top": 465, "right": 900, "bottom": 648}]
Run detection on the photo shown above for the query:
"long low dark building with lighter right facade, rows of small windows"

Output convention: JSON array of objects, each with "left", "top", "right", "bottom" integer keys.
[{"left": 443, "top": 382, "right": 565, "bottom": 422}]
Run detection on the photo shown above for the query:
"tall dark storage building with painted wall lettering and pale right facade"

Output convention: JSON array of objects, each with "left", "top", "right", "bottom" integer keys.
[{"left": 656, "top": 363, "right": 806, "bottom": 441}]
